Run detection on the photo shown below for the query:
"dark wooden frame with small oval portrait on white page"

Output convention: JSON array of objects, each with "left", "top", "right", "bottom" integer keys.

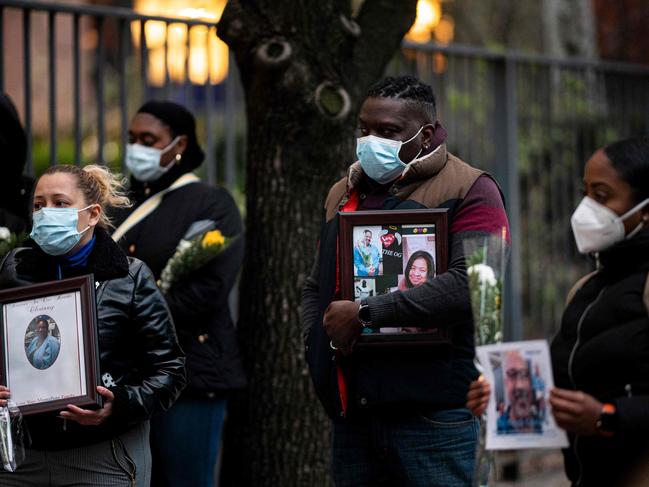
[{"left": 0, "top": 276, "right": 101, "bottom": 415}]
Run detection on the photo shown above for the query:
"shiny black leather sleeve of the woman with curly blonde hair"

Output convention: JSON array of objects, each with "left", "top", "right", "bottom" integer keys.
[{"left": 111, "top": 262, "right": 186, "bottom": 422}]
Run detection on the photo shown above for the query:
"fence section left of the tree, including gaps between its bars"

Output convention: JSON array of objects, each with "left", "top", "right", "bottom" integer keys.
[{"left": 0, "top": 0, "right": 245, "bottom": 187}]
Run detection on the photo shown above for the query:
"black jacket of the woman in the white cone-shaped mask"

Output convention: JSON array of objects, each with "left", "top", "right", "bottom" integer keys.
[{"left": 552, "top": 229, "right": 649, "bottom": 486}]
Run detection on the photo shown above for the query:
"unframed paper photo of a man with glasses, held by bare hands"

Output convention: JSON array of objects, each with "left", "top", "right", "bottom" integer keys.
[{"left": 477, "top": 340, "right": 568, "bottom": 450}]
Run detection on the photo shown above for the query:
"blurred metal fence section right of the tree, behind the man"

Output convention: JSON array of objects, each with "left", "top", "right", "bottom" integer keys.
[{"left": 398, "top": 43, "right": 649, "bottom": 339}]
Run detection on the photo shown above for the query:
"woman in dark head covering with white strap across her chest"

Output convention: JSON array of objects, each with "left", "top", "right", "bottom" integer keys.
[{"left": 113, "top": 101, "right": 246, "bottom": 487}]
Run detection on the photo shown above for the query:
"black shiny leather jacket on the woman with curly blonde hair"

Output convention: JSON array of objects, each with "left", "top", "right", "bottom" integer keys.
[{"left": 0, "top": 229, "right": 185, "bottom": 449}]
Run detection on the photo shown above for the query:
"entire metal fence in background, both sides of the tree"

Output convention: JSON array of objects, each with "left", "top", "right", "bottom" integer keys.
[{"left": 0, "top": 0, "right": 649, "bottom": 338}]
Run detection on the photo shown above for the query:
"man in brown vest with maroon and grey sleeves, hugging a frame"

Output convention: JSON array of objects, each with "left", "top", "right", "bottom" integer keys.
[{"left": 302, "top": 77, "right": 509, "bottom": 487}]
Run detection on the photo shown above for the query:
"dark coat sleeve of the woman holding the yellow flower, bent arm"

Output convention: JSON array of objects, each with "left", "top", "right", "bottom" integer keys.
[{"left": 161, "top": 189, "right": 244, "bottom": 329}]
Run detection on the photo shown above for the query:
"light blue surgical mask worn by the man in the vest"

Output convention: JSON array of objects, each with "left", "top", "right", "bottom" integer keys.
[{"left": 356, "top": 125, "right": 425, "bottom": 184}]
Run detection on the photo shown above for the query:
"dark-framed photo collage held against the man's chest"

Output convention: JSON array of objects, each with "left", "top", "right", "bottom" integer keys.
[{"left": 339, "top": 209, "right": 450, "bottom": 347}]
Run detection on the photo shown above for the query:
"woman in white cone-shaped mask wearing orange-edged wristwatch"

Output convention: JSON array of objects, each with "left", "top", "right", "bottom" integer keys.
[{"left": 467, "top": 136, "right": 649, "bottom": 487}]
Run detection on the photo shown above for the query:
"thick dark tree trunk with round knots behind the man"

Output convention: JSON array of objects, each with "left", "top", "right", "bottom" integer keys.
[{"left": 218, "top": 0, "right": 416, "bottom": 486}]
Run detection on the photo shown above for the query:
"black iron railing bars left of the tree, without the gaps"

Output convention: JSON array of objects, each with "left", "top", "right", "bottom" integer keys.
[{"left": 0, "top": 0, "right": 242, "bottom": 186}]
